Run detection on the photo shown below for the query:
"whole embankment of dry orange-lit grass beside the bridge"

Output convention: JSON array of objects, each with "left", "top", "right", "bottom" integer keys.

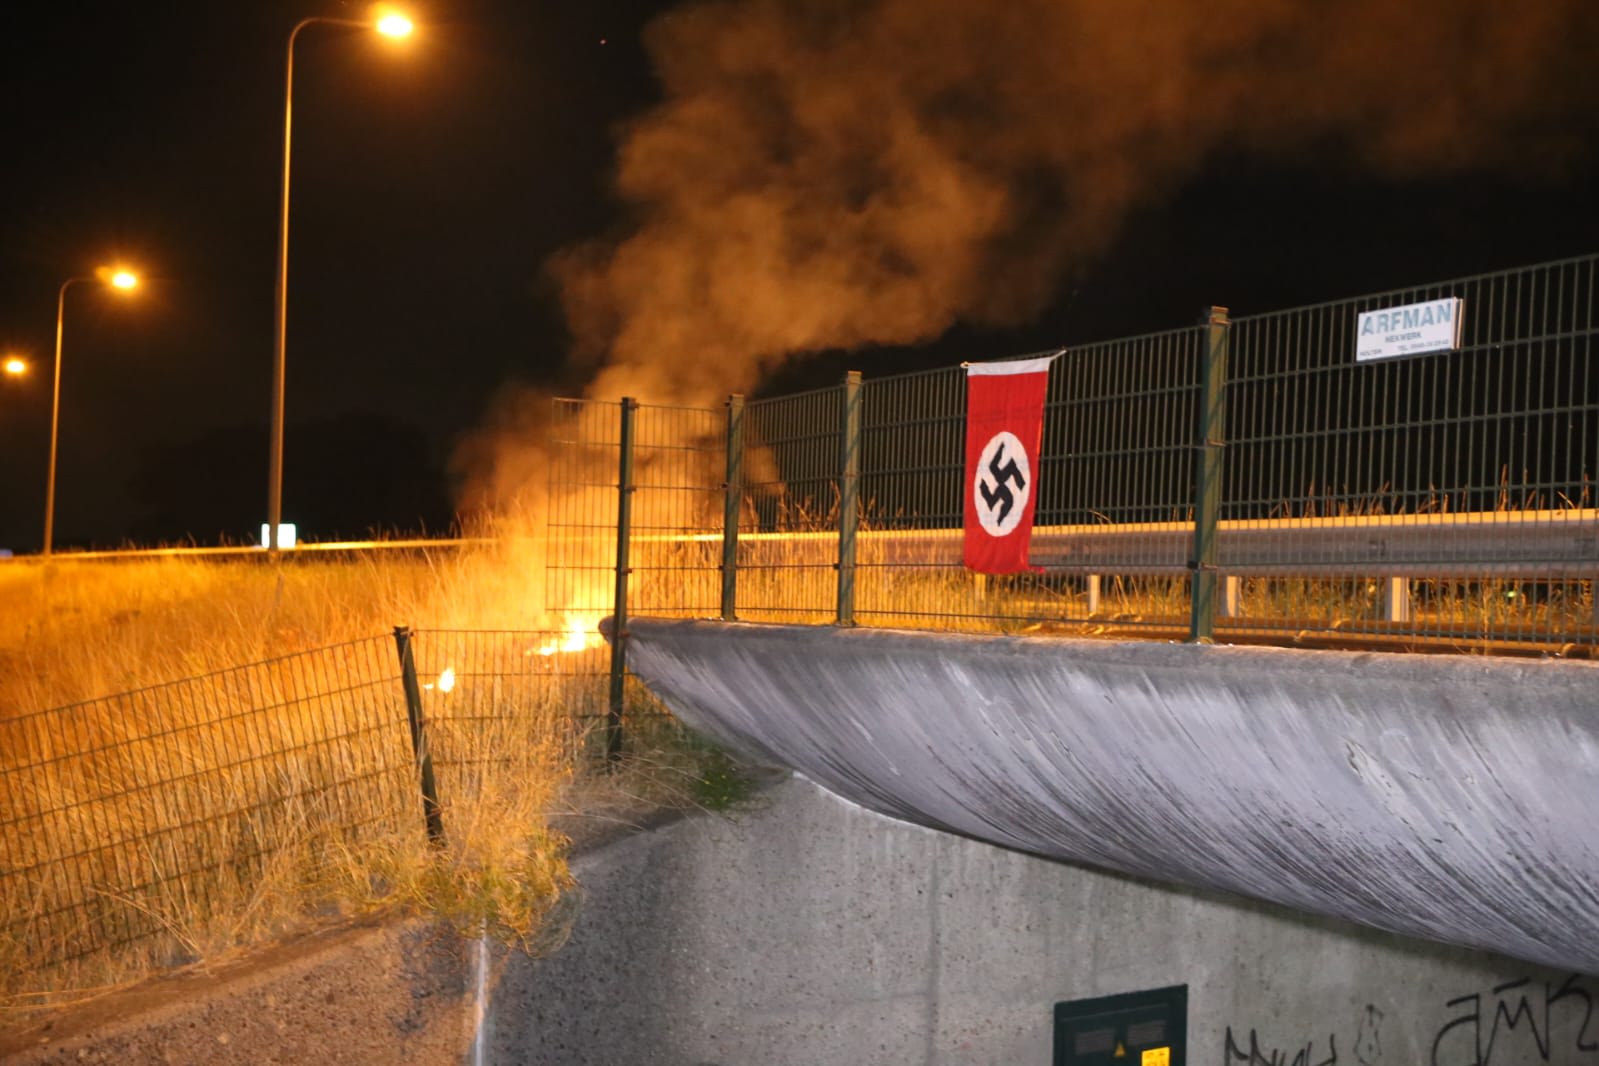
[{"left": 0, "top": 537, "right": 751, "bottom": 1024}]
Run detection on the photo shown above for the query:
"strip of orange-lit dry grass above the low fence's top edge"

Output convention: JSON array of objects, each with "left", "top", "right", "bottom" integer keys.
[{"left": 0, "top": 537, "right": 556, "bottom": 714}]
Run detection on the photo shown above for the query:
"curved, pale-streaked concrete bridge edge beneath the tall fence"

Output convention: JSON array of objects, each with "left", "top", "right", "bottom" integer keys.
[{"left": 628, "top": 619, "right": 1599, "bottom": 973}]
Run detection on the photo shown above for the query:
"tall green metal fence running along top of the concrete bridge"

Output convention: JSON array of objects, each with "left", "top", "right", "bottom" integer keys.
[{"left": 585, "top": 257, "right": 1599, "bottom": 654}]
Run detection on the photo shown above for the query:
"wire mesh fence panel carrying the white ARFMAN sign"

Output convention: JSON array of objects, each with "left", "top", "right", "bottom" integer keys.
[{"left": 1218, "top": 257, "right": 1599, "bottom": 649}]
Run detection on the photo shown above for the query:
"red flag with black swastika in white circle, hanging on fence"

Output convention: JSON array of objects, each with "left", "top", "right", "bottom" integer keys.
[{"left": 963, "top": 352, "right": 1060, "bottom": 574}]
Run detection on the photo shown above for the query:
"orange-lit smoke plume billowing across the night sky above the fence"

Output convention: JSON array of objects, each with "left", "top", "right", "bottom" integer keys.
[{"left": 555, "top": 0, "right": 1599, "bottom": 403}]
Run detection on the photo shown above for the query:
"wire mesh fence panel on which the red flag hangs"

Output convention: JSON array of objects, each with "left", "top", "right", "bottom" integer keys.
[{"left": 857, "top": 331, "right": 1199, "bottom": 630}]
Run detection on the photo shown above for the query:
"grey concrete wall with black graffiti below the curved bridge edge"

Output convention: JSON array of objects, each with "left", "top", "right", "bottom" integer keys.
[{"left": 0, "top": 778, "right": 1599, "bottom": 1066}]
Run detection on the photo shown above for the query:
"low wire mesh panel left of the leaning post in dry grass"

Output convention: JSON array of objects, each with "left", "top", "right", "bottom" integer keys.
[{"left": 0, "top": 639, "right": 417, "bottom": 962}]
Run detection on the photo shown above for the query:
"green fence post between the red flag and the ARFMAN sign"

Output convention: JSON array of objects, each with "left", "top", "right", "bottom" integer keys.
[{"left": 1188, "top": 307, "right": 1233, "bottom": 644}]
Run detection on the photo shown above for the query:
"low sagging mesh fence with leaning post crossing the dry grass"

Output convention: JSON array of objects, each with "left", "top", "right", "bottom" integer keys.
[{"left": 0, "top": 630, "right": 617, "bottom": 994}]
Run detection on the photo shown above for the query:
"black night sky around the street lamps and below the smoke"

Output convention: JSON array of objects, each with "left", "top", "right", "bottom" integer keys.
[{"left": 0, "top": 0, "right": 1599, "bottom": 551}]
